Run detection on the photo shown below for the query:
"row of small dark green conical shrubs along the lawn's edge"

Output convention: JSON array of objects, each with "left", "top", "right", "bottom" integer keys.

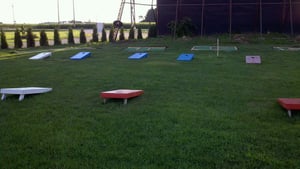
[{"left": 0, "top": 25, "right": 157, "bottom": 49}]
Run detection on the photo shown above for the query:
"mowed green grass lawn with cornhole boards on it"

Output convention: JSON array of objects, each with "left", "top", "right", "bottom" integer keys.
[{"left": 0, "top": 36, "right": 300, "bottom": 169}]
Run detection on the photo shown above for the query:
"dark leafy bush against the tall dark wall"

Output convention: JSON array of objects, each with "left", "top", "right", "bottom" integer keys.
[{"left": 168, "top": 17, "right": 196, "bottom": 37}]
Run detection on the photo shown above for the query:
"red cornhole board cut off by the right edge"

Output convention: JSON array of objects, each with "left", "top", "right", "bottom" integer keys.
[{"left": 278, "top": 98, "right": 300, "bottom": 117}]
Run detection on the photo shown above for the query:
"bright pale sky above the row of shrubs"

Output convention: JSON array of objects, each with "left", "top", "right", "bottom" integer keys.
[{"left": 0, "top": 0, "right": 156, "bottom": 24}]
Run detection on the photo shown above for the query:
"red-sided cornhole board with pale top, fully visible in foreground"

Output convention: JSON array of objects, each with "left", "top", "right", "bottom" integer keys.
[{"left": 100, "top": 89, "right": 144, "bottom": 104}]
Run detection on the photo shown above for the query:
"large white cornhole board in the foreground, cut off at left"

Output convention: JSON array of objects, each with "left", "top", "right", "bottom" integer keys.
[{"left": 0, "top": 87, "right": 52, "bottom": 101}]
